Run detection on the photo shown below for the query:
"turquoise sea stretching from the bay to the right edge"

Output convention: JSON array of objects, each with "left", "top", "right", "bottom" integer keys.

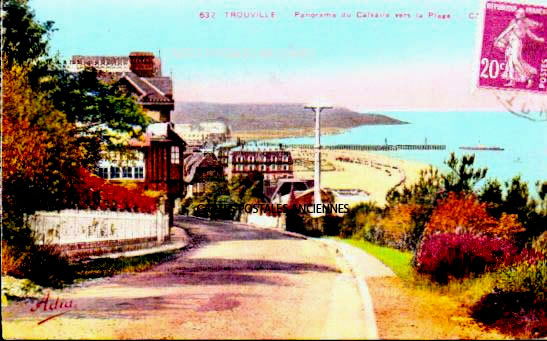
[{"left": 276, "top": 112, "right": 547, "bottom": 195}]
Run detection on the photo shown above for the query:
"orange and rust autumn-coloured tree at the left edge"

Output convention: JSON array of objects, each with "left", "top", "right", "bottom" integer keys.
[{"left": 2, "top": 64, "right": 98, "bottom": 231}]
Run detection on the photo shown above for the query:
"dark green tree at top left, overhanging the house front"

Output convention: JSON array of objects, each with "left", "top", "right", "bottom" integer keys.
[{"left": 2, "top": 0, "right": 150, "bottom": 152}]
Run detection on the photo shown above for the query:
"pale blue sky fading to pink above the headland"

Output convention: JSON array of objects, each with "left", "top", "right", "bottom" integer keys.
[{"left": 29, "top": 0, "right": 540, "bottom": 111}]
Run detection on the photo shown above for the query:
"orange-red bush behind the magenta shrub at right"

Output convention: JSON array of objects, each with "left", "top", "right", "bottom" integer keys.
[{"left": 425, "top": 193, "right": 524, "bottom": 239}]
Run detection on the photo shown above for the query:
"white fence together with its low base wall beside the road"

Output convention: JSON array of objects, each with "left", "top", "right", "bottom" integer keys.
[{"left": 27, "top": 210, "right": 169, "bottom": 256}]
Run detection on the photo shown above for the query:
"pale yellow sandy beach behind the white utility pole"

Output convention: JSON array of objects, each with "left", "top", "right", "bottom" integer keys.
[{"left": 290, "top": 148, "right": 429, "bottom": 206}]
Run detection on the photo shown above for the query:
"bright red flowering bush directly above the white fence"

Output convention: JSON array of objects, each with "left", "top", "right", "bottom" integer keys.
[{"left": 75, "top": 169, "right": 157, "bottom": 213}]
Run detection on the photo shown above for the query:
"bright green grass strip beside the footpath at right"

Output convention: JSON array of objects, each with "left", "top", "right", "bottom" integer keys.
[{"left": 336, "top": 238, "right": 414, "bottom": 280}]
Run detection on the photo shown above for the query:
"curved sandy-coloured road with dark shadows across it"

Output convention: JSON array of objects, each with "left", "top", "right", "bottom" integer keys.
[{"left": 2, "top": 217, "right": 367, "bottom": 339}]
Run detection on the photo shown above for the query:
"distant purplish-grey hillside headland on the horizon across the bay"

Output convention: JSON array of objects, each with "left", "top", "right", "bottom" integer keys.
[{"left": 171, "top": 102, "right": 406, "bottom": 132}]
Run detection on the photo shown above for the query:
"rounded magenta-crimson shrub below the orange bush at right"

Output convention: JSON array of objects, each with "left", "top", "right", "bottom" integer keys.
[{"left": 416, "top": 233, "right": 518, "bottom": 283}]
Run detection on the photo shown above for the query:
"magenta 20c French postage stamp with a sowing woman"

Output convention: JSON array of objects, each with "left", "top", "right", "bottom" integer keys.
[{"left": 475, "top": 1, "right": 547, "bottom": 94}]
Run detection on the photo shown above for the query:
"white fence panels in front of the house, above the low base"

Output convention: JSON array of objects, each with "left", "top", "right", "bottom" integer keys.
[{"left": 28, "top": 210, "right": 169, "bottom": 245}]
